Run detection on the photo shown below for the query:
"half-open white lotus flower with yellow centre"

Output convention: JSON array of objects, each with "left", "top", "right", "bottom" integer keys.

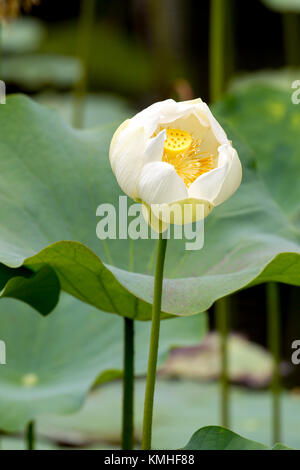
[{"left": 109, "top": 99, "right": 242, "bottom": 228}]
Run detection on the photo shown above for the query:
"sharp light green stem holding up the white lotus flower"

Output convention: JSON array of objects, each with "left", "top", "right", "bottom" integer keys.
[{"left": 142, "top": 233, "right": 167, "bottom": 450}]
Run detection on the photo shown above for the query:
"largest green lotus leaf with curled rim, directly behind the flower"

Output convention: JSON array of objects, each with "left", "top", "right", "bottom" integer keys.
[{"left": 0, "top": 91, "right": 300, "bottom": 320}]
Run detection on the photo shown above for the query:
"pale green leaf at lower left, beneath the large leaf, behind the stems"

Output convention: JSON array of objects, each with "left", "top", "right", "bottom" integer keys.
[{"left": 0, "top": 294, "right": 206, "bottom": 431}]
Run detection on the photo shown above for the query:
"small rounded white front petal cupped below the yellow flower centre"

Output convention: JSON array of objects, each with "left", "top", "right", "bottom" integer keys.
[{"left": 138, "top": 162, "right": 187, "bottom": 205}]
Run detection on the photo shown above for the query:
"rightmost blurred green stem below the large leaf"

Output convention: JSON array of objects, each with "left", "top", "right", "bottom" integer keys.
[{"left": 267, "top": 283, "right": 281, "bottom": 444}]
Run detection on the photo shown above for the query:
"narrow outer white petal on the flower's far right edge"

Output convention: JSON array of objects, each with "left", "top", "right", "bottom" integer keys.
[{"left": 213, "top": 147, "right": 242, "bottom": 206}]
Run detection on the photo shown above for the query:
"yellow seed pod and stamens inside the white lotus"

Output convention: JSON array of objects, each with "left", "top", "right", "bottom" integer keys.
[{"left": 163, "top": 129, "right": 215, "bottom": 188}]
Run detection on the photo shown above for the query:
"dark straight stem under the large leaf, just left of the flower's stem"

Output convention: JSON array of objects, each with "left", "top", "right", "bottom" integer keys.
[{"left": 122, "top": 318, "right": 134, "bottom": 450}]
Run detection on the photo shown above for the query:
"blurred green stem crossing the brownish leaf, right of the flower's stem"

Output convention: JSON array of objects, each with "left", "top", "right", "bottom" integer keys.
[{"left": 215, "top": 297, "right": 230, "bottom": 428}]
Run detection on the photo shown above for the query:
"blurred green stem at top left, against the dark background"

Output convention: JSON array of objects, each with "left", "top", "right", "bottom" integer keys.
[{"left": 73, "top": 0, "right": 96, "bottom": 128}]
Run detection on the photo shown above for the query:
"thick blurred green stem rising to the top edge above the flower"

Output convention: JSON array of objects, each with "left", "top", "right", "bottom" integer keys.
[{"left": 209, "top": 0, "right": 226, "bottom": 103}]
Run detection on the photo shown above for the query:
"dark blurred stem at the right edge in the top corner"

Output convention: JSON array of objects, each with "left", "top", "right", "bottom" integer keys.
[{"left": 282, "top": 13, "right": 300, "bottom": 67}]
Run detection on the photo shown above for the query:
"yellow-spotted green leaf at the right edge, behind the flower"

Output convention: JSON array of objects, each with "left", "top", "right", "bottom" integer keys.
[{"left": 217, "top": 85, "right": 300, "bottom": 235}]
